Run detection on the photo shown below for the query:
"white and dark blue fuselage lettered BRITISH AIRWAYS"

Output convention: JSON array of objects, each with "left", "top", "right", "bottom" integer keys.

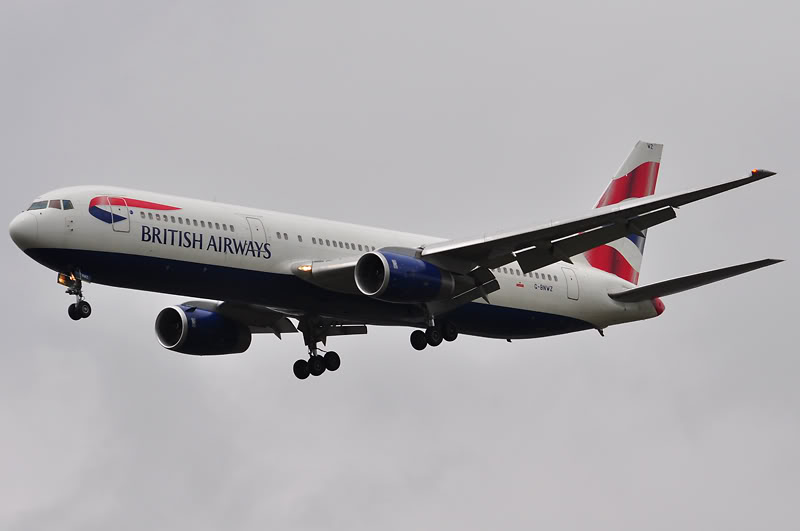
[{"left": 7, "top": 186, "right": 657, "bottom": 338}]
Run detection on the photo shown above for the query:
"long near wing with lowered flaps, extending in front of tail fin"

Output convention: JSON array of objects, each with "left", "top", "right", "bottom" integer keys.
[{"left": 421, "top": 170, "right": 775, "bottom": 274}]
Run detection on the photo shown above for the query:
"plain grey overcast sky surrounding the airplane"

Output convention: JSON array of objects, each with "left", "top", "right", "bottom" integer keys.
[{"left": 0, "top": 0, "right": 800, "bottom": 530}]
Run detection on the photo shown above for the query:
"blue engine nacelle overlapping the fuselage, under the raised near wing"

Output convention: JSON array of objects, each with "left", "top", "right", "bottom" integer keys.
[{"left": 355, "top": 250, "right": 455, "bottom": 303}]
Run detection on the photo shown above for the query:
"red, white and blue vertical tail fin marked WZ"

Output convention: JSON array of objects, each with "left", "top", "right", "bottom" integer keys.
[{"left": 583, "top": 141, "right": 664, "bottom": 284}]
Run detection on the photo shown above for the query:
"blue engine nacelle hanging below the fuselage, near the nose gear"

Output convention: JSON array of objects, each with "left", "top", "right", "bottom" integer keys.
[{"left": 156, "top": 304, "right": 251, "bottom": 356}]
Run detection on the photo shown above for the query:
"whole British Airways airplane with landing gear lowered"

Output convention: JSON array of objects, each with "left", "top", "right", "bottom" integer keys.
[{"left": 9, "top": 141, "right": 781, "bottom": 380}]
